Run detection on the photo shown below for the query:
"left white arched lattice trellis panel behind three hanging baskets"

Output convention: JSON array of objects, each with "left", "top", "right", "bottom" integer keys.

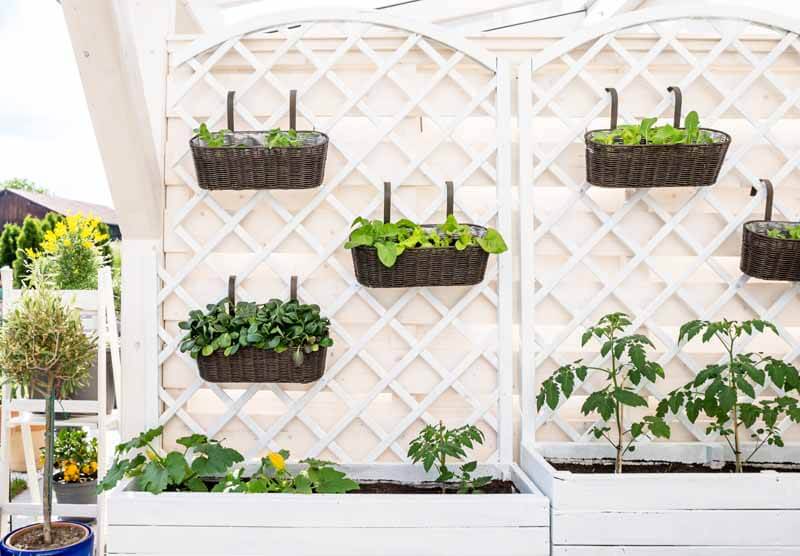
[{"left": 158, "top": 10, "right": 513, "bottom": 462}]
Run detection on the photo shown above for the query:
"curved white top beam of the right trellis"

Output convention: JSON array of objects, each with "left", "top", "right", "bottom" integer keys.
[{"left": 531, "top": 4, "right": 800, "bottom": 71}]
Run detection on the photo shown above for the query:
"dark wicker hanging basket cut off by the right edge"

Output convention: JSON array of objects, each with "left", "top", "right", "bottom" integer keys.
[{"left": 739, "top": 180, "right": 800, "bottom": 282}]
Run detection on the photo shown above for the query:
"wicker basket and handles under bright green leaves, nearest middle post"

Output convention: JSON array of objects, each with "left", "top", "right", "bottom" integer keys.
[{"left": 352, "top": 181, "right": 489, "bottom": 288}]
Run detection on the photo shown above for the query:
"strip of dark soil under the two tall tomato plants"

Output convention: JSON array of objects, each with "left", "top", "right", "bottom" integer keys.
[{"left": 547, "top": 460, "right": 800, "bottom": 474}]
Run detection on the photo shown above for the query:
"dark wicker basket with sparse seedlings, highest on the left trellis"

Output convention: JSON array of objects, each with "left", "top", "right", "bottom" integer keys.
[{"left": 189, "top": 91, "right": 328, "bottom": 190}]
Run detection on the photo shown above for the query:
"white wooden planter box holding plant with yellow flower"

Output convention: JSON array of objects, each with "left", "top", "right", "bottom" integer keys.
[{"left": 107, "top": 464, "right": 550, "bottom": 556}]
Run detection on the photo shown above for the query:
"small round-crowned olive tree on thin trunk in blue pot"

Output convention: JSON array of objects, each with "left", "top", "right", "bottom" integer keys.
[{"left": 0, "top": 271, "right": 97, "bottom": 556}]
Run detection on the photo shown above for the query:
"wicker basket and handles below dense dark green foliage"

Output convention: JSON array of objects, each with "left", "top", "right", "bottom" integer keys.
[{"left": 197, "top": 276, "right": 327, "bottom": 384}]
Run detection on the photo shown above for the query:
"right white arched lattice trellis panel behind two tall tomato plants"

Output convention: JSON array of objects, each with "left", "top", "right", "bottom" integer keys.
[{"left": 518, "top": 5, "right": 800, "bottom": 460}]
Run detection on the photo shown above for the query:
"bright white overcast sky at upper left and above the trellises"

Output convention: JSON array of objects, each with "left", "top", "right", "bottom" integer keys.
[{"left": 0, "top": 0, "right": 800, "bottom": 205}]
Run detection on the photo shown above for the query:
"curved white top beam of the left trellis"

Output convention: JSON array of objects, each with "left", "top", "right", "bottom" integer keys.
[{"left": 171, "top": 8, "right": 497, "bottom": 71}]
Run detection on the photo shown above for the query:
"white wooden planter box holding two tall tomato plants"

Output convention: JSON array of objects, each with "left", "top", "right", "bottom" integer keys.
[{"left": 521, "top": 445, "right": 800, "bottom": 556}]
